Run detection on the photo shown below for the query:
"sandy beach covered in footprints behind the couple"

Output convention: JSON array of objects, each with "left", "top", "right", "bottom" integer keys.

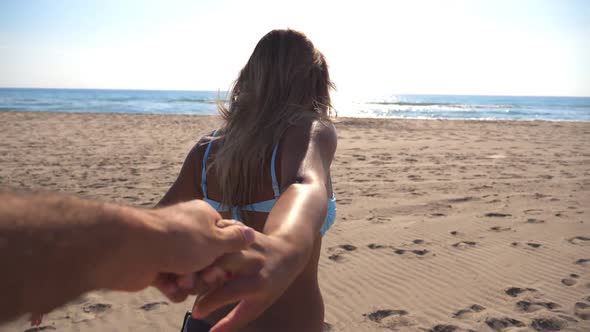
[{"left": 0, "top": 112, "right": 590, "bottom": 332}]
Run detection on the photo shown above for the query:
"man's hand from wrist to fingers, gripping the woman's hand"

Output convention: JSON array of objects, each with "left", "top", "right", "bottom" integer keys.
[{"left": 100, "top": 200, "right": 256, "bottom": 302}]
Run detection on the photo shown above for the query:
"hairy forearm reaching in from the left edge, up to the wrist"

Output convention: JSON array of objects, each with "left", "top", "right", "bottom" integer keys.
[{"left": 0, "top": 191, "right": 158, "bottom": 321}]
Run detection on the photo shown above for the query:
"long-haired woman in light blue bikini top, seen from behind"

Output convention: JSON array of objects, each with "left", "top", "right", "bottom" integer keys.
[{"left": 160, "top": 30, "right": 337, "bottom": 332}]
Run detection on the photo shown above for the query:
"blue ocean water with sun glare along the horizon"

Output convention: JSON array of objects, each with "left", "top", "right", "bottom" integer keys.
[{"left": 0, "top": 88, "right": 590, "bottom": 121}]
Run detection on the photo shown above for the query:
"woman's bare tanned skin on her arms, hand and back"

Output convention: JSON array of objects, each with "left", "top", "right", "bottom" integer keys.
[{"left": 161, "top": 120, "right": 337, "bottom": 332}]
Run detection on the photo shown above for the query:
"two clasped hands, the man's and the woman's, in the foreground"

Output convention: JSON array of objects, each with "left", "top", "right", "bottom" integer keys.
[{"left": 31, "top": 200, "right": 307, "bottom": 332}]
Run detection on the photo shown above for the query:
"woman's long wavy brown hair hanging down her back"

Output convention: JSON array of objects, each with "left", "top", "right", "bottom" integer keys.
[{"left": 211, "top": 30, "right": 334, "bottom": 210}]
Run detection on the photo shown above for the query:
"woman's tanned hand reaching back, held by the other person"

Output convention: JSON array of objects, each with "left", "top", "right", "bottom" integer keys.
[{"left": 193, "top": 220, "right": 306, "bottom": 332}]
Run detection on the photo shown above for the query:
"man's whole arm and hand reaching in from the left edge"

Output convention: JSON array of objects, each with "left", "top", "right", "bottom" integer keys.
[{"left": 0, "top": 190, "right": 254, "bottom": 321}]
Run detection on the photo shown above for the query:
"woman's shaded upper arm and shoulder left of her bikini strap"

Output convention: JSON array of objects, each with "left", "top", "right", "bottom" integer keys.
[{"left": 156, "top": 141, "right": 205, "bottom": 207}]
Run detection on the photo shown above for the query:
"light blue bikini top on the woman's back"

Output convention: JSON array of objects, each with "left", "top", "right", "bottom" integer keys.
[{"left": 201, "top": 131, "right": 336, "bottom": 236}]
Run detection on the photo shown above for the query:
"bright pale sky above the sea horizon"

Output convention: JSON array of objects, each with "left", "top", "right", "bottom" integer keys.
[{"left": 0, "top": 0, "right": 590, "bottom": 96}]
